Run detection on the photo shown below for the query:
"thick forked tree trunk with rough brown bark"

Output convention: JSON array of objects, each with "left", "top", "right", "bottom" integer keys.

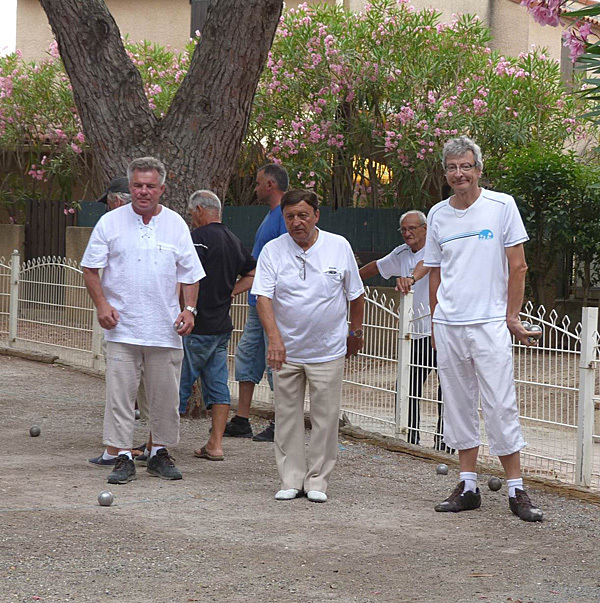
[{"left": 40, "top": 0, "right": 283, "bottom": 214}]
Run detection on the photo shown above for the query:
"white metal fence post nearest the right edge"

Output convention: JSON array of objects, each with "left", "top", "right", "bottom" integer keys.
[{"left": 575, "top": 308, "right": 598, "bottom": 487}]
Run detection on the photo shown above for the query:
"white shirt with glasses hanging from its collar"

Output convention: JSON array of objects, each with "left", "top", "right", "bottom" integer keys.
[{"left": 252, "top": 230, "right": 364, "bottom": 364}]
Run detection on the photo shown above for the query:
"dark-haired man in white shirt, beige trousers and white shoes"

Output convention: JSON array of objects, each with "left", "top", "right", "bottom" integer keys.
[{"left": 252, "top": 190, "right": 364, "bottom": 502}]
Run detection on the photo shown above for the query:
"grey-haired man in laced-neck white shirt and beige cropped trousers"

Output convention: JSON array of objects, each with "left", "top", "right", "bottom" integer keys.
[{"left": 81, "top": 157, "right": 205, "bottom": 484}]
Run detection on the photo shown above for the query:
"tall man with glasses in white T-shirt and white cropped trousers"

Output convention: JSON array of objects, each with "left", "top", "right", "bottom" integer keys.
[{"left": 424, "top": 136, "right": 543, "bottom": 521}]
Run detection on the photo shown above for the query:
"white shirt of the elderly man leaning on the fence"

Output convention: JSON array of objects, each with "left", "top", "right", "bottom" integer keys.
[{"left": 377, "top": 244, "right": 431, "bottom": 339}]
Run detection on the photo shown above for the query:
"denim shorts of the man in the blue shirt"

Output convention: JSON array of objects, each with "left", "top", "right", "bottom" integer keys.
[{"left": 235, "top": 306, "right": 273, "bottom": 389}]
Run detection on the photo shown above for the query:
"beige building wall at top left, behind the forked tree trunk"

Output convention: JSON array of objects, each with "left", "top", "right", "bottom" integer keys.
[{"left": 17, "top": 0, "right": 191, "bottom": 61}]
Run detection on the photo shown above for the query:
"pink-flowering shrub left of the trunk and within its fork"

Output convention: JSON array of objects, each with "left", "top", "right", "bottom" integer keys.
[{"left": 0, "top": 35, "right": 196, "bottom": 221}]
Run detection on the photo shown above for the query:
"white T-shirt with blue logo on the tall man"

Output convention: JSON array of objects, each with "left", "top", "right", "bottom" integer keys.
[{"left": 424, "top": 189, "right": 529, "bottom": 325}]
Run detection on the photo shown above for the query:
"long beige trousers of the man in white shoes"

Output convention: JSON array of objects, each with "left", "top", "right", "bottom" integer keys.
[{"left": 273, "top": 357, "right": 344, "bottom": 492}]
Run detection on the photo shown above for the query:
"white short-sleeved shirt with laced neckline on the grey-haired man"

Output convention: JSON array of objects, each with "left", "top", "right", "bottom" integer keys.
[{"left": 81, "top": 204, "right": 205, "bottom": 349}]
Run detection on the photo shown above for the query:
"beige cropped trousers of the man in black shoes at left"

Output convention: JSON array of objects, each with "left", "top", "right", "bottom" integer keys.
[{"left": 104, "top": 341, "right": 183, "bottom": 449}]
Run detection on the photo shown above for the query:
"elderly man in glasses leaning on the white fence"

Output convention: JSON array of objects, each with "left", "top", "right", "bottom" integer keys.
[{"left": 360, "top": 209, "right": 450, "bottom": 451}]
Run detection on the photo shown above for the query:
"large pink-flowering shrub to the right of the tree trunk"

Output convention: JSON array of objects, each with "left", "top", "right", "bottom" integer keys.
[{"left": 241, "top": 0, "right": 589, "bottom": 207}]
